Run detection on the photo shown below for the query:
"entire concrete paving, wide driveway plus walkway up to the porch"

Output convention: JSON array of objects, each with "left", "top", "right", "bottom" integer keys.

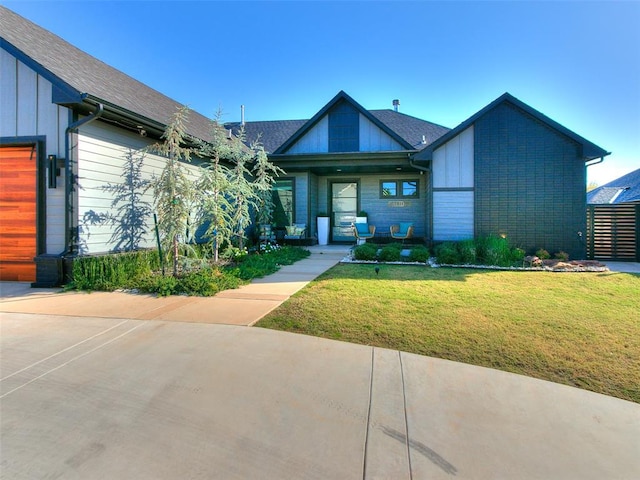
[{"left": 0, "top": 250, "right": 640, "bottom": 480}]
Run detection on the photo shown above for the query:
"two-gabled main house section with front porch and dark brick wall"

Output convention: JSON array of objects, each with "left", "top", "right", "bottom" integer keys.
[{"left": 234, "top": 92, "right": 609, "bottom": 258}]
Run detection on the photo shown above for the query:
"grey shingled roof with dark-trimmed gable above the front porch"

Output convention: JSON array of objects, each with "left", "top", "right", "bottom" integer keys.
[{"left": 225, "top": 91, "right": 449, "bottom": 154}]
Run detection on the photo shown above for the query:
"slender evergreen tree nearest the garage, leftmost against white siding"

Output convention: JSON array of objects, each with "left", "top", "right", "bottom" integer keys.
[{"left": 148, "top": 107, "right": 195, "bottom": 276}]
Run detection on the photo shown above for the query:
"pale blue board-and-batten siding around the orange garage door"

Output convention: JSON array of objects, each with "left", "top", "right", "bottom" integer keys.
[{"left": 0, "top": 49, "right": 69, "bottom": 254}]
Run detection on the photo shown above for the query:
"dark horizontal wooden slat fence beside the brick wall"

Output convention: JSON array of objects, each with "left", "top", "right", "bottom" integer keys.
[{"left": 587, "top": 203, "right": 640, "bottom": 262}]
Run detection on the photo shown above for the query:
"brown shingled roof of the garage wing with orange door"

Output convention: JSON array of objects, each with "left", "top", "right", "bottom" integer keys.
[{"left": 0, "top": 6, "right": 215, "bottom": 139}]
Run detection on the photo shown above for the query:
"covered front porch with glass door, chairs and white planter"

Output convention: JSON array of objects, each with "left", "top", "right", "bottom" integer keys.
[{"left": 274, "top": 152, "right": 431, "bottom": 244}]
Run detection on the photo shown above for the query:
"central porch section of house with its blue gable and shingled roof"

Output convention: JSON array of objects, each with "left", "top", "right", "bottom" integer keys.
[{"left": 227, "top": 92, "right": 449, "bottom": 243}]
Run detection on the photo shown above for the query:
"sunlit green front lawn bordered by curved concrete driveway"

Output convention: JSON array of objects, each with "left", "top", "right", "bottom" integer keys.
[{"left": 257, "top": 264, "right": 640, "bottom": 403}]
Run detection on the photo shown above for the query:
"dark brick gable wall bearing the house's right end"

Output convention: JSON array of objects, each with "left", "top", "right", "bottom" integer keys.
[{"left": 475, "top": 103, "right": 586, "bottom": 259}]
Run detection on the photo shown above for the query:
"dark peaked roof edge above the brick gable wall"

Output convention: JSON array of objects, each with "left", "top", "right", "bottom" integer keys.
[{"left": 414, "top": 93, "right": 611, "bottom": 161}]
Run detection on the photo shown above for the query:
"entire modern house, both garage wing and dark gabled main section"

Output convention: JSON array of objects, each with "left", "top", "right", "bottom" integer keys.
[{"left": 0, "top": 7, "right": 608, "bottom": 286}]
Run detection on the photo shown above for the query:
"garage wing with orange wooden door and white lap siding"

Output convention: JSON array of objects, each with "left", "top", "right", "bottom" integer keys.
[{"left": 0, "top": 6, "right": 215, "bottom": 286}]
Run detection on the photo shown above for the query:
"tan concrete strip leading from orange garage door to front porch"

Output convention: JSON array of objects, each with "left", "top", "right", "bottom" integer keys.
[{"left": 0, "top": 245, "right": 349, "bottom": 326}]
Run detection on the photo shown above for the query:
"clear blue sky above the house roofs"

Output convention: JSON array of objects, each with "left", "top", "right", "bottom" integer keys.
[{"left": 3, "top": 0, "right": 640, "bottom": 185}]
